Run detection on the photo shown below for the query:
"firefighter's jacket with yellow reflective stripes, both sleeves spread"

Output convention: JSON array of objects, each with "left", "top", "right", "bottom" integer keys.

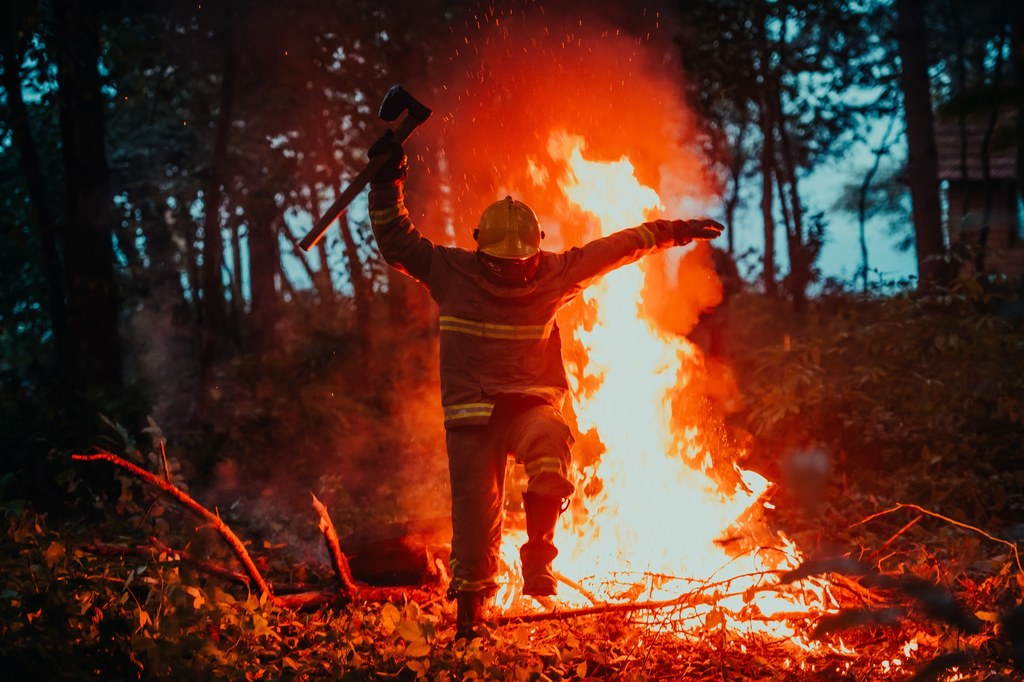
[{"left": 370, "top": 182, "right": 676, "bottom": 428}]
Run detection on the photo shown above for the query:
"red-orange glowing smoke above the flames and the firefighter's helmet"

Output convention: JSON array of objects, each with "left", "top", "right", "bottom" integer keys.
[{"left": 413, "top": 3, "right": 711, "bottom": 248}]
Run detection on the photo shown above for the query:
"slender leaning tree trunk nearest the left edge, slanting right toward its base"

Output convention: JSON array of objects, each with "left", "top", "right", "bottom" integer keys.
[{"left": 0, "top": 3, "right": 68, "bottom": 377}]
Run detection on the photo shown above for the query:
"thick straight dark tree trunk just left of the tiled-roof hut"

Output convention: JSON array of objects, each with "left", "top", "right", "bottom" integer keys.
[{"left": 896, "top": 0, "right": 948, "bottom": 289}]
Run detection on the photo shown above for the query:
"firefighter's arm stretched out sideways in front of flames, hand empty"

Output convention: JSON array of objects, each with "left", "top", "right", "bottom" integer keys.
[{"left": 564, "top": 218, "right": 723, "bottom": 289}]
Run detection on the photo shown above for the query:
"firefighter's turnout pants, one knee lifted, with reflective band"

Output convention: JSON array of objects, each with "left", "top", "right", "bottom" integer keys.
[{"left": 446, "top": 397, "right": 573, "bottom": 594}]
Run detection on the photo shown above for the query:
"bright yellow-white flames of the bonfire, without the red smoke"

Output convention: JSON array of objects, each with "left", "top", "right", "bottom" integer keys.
[{"left": 491, "top": 131, "right": 824, "bottom": 636}]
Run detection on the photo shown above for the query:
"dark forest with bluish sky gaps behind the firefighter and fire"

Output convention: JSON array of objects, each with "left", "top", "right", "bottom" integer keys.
[{"left": 0, "top": 0, "right": 1024, "bottom": 670}]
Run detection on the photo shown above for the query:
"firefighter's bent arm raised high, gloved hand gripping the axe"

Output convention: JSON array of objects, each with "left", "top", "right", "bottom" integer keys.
[{"left": 369, "top": 131, "right": 435, "bottom": 283}]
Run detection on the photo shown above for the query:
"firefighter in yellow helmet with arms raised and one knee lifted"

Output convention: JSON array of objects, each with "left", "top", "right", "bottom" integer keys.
[{"left": 370, "top": 136, "right": 722, "bottom": 637}]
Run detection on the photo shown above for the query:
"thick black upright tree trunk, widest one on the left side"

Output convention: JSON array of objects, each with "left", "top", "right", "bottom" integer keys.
[{"left": 53, "top": 0, "right": 122, "bottom": 394}]
